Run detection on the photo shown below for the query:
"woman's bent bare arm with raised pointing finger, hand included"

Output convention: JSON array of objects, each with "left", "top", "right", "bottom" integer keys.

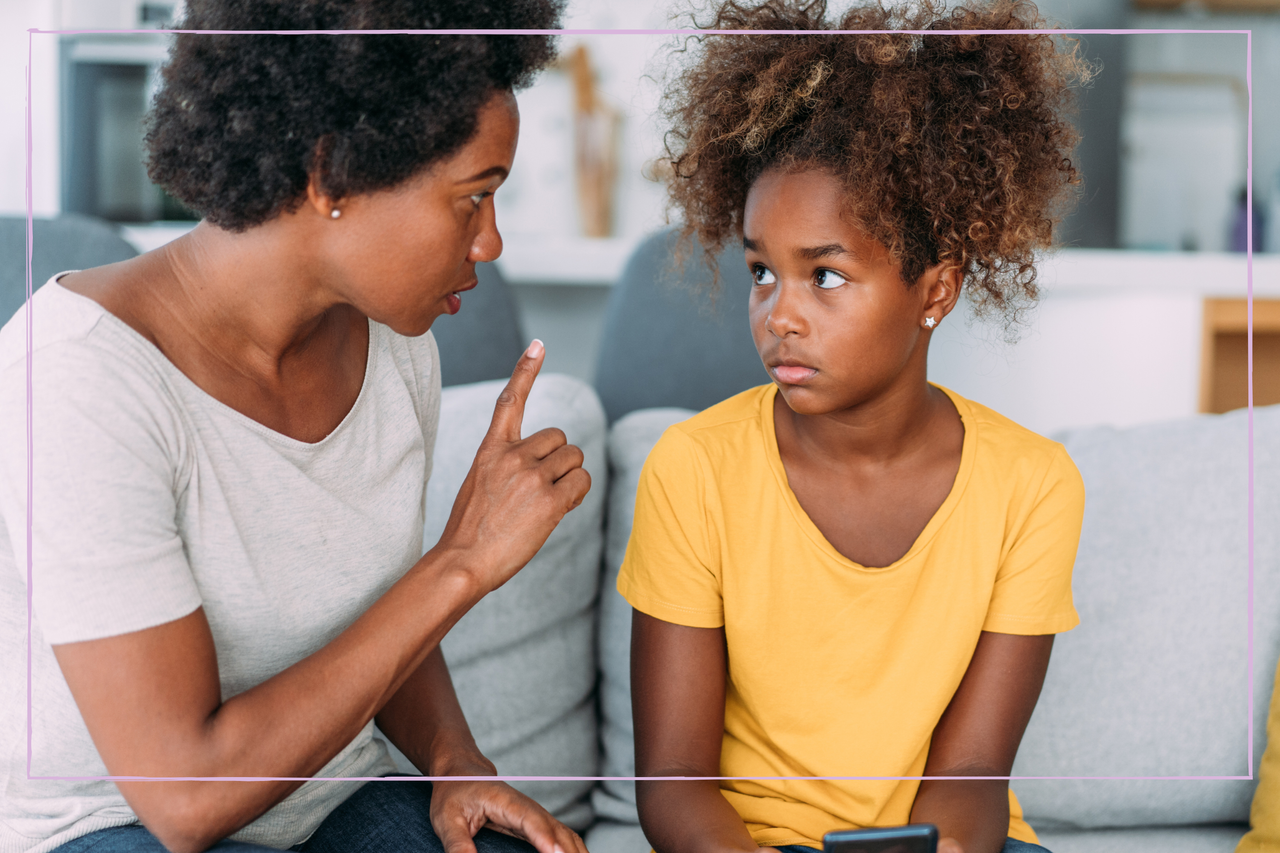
[{"left": 54, "top": 352, "right": 590, "bottom": 853}]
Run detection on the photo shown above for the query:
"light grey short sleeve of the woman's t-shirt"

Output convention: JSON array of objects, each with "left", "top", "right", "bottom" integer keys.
[{"left": 0, "top": 342, "right": 201, "bottom": 644}]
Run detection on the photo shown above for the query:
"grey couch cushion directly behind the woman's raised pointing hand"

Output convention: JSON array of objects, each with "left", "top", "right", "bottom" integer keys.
[{"left": 376, "top": 374, "right": 608, "bottom": 829}]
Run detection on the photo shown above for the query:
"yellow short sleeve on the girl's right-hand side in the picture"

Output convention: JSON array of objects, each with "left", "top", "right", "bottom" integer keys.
[{"left": 982, "top": 446, "right": 1084, "bottom": 634}]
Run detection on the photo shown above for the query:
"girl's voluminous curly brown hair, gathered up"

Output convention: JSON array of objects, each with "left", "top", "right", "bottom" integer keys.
[{"left": 664, "top": 0, "right": 1093, "bottom": 328}]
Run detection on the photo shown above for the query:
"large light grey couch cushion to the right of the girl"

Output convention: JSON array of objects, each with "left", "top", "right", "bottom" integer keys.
[{"left": 1014, "top": 406, "right": 1280, "bottom": 827}]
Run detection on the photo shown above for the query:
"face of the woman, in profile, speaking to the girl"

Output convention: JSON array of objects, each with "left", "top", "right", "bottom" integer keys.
[{"left": 312, "top": 92, "right": 520, "bottom": 336}]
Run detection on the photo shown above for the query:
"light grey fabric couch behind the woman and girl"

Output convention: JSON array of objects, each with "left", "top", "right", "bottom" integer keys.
[{"left": 414, "top": 375, "right": 1280, "bottom": 853}]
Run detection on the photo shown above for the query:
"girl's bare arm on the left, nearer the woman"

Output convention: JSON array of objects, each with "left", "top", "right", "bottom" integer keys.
[{"left": 631, "top": 610, "right": 760, "bottom": 853}]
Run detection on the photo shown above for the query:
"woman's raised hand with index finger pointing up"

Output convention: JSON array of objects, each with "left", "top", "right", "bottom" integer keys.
[{"left": 433, "top": 341, "right": 591, "bottom": 591}]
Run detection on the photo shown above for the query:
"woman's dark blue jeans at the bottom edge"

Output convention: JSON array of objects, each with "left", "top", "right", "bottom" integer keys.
[{"left": 54, "top": 781, "right": 534, "bottom": 853}]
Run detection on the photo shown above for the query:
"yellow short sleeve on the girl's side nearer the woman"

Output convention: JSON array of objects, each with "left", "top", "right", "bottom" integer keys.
[{"left": 618, "top": 427, "right": 724, "bottom": 628}]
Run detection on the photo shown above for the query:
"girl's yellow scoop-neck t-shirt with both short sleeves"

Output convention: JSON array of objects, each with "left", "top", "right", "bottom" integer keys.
[{"left": 618, "top": 386, "right": 1084, "bottom": 847}]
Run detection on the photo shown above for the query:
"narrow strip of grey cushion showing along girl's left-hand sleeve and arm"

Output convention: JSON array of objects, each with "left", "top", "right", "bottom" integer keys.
[{"left": 589, "top": 409, "right": 695, "bottom": 819}]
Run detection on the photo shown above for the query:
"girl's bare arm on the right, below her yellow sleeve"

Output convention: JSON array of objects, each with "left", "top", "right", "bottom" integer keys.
[{"left": 911, "top": 631, "right": 1053, "bottom": 853}]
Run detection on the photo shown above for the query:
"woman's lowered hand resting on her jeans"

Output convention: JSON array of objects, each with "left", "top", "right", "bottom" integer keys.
[{"left": 431, "top": 781, "right": 586, "bottom": 853}]
